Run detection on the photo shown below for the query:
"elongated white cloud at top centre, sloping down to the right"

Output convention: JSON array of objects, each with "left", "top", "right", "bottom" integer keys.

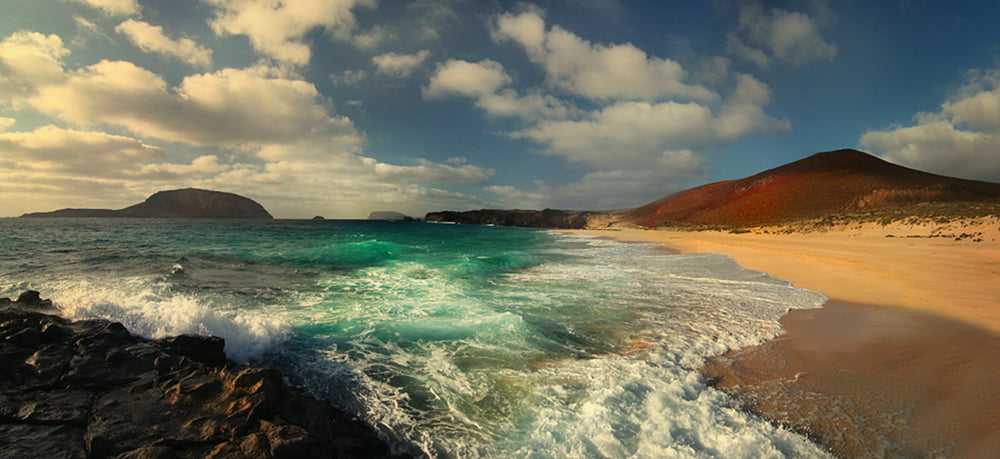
[{"left": 493, "top": 10, "right": 717, "bottom": 101}]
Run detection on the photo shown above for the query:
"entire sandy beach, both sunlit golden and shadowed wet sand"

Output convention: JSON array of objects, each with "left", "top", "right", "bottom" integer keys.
[{"left": 564, "top": 221, "right": 1000, "bottom": 457}]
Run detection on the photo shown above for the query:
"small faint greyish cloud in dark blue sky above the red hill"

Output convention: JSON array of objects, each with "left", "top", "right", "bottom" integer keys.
[{"left": 726, "top": 3, "right": 837, "bottom": 67}]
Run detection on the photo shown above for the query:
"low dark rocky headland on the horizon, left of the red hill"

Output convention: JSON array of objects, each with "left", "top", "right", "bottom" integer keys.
[{"left": 424, "top": 209, "right": 611, "bottom": 229}]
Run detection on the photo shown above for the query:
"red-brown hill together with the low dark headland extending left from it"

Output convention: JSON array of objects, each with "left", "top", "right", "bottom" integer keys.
[{"left": 425, "top": 149, "right": 1000, "bottom": 229}]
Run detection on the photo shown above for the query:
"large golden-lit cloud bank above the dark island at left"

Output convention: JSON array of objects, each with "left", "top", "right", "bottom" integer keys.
[{"left": 0, "top": 32, "right": 493, "bottom": 217}]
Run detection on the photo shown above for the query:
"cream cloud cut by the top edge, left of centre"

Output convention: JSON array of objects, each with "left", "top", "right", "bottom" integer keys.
[{"left": 203, "top": 0, "right": 375, "bottom": 66}]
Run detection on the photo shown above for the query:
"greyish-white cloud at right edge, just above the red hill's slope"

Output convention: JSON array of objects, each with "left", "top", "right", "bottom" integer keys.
[{"left": 859, "top": 70, "right": 1000, "bottom": 181}]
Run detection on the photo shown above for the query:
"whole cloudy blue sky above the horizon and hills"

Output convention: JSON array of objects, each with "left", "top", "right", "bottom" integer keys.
[{"left": 0, "top": 0, "right": 1000, "bottom": 218}]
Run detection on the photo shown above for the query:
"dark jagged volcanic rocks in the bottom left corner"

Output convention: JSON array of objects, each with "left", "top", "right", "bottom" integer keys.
[{"left": 0, "top": 291, "right": 402, "bottom": 458}]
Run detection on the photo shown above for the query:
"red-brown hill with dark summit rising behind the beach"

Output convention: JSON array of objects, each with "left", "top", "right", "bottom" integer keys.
[{"left": 624, "top": 150, "right": 1000, "bottom": 227}]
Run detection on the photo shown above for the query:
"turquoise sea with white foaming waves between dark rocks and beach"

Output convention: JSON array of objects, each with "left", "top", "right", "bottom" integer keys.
[{"left": 0, "top": 219, "right": 826, "bottom": 458}]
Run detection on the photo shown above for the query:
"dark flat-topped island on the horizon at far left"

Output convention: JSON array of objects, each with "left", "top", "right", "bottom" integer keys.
[{"left": 21, "top": 188, "right": 274, "bottom": 219}]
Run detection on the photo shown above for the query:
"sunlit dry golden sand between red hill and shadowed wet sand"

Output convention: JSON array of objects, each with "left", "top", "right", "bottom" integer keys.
[{"left": 568, "top": 217, "right": 1000, "bottom": 332}]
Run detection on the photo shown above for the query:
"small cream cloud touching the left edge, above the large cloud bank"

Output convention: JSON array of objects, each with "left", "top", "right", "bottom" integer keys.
[{"left": 0, "top": 31, "right": 69, "bottom": 106}]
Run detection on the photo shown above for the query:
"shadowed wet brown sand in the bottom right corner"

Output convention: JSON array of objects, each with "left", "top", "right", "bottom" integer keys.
[{"left": 702, "top": 302, "right": 1000, "bottom": 457}]
